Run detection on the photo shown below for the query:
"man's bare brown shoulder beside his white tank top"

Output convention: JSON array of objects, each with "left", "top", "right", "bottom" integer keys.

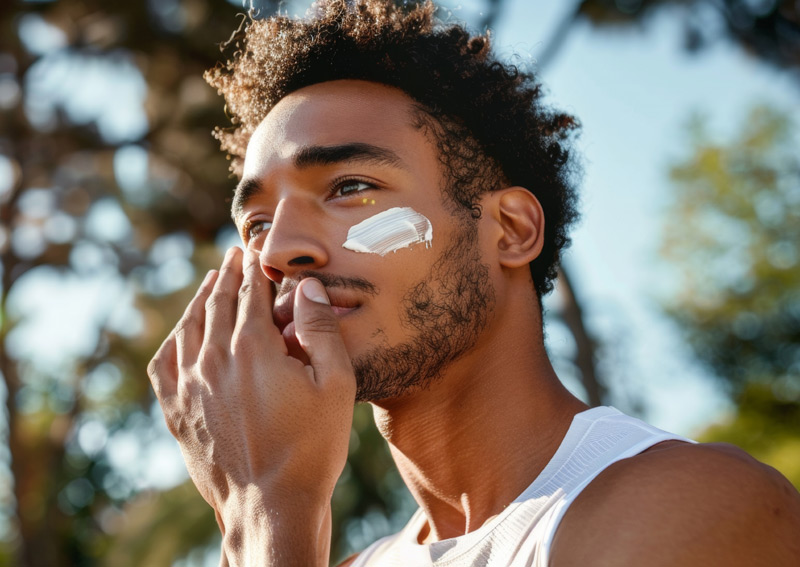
[{"left": 550, "top": 441, "right": 800, "bottom": 567}]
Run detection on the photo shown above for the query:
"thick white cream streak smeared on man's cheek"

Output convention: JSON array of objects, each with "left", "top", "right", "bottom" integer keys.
[{"left": 342, "top": 207, "right": 433, "bottom": 256}]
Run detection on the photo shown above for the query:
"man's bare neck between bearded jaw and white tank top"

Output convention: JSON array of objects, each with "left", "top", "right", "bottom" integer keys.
[{"left": 374, "top": 298, "right": 587, "bottom": 542}]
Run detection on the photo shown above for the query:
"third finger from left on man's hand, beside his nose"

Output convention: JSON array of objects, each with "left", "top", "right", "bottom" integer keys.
[{"left": 234, "top": 250, "right": 283, "bottom": 344}]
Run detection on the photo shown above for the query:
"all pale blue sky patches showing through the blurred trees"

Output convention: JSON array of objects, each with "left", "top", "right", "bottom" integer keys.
[{"left": 0, "top": 0, "right": 800, "bottom": 564}]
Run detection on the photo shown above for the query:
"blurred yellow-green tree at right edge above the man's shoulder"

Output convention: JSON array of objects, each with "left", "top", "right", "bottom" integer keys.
[{"left": 664, "top": 107, "right": 800, "bottom": 486}]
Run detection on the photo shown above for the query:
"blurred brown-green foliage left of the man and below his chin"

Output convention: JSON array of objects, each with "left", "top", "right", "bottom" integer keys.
[{"left": 0, "top": 0, "right": 409, "bottom": 567}]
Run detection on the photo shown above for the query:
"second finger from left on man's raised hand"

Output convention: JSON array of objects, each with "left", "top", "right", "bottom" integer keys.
[{"left": 203, "top": 246, "right": 242, "bottom": 348}]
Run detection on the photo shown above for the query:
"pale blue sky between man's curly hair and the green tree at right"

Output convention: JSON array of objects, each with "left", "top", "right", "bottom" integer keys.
[{"left": 488, "top": 0, "right": 800, "bottom": 434}]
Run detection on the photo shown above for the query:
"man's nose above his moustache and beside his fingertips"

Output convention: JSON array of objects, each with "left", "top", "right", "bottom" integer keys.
[{"left": 260, "top": 199, "right": 328, "bottom": 284}]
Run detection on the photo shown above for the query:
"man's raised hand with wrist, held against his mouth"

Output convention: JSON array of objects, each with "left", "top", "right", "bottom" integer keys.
[{"left": 148, "top": 248, "right": 355, "bottom": 565}]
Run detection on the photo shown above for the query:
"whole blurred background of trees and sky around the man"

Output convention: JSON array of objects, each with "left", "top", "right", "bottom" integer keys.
[{"left": 0, "top": 0, "right": 800, "bottom": 567}]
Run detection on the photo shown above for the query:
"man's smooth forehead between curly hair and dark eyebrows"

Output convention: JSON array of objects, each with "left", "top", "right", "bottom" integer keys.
[{"left": 243, "top": 80, "right": 432, "bottom": 178}]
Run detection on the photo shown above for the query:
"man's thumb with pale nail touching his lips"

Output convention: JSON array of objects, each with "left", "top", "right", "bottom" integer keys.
[{"left": 294, "top": 278, "right": 355, "bottom": 396}]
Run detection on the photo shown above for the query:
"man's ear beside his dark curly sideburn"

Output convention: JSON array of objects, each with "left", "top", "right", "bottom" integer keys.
[{"left": 484, "top": 187, "right": 544, "bottom": 268}]
